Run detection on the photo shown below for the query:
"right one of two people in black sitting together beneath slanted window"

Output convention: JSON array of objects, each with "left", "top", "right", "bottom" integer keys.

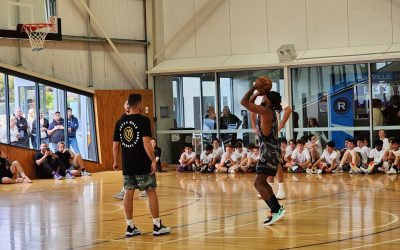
[{"left": 55, "top": 141, "right": 91, "bottom": 176}]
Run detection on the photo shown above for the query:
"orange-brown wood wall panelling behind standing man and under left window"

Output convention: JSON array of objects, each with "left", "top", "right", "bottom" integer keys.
[{"left": 0, "top": 90, "right": 155, "bottom": 179}]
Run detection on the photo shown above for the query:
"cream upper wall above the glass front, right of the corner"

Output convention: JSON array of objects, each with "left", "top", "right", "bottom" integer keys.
[{"left": 155, "top": 0, "right": 400, "bottom": 70}]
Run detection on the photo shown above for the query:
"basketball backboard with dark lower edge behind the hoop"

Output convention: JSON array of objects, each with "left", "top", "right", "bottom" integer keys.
[{"left": 0, "top": 0, "right": 62, "bottom": 40}]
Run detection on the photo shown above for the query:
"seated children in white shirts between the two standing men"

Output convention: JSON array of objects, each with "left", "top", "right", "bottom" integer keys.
[{"left": 177, "top": 138, "right": 259, "bottom": 173}]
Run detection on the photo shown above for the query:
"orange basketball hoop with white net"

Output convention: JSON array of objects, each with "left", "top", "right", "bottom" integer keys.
[{"left": 21, "top": 17, "right": 57, "bottom": 51}]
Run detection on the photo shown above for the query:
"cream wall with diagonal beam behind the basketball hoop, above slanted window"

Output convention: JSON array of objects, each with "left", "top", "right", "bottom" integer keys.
[{"left": 0, "top": 0, "right": 146, "bottom": 89}]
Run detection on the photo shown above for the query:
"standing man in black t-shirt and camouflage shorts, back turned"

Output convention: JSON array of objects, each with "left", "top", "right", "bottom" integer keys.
[{"left": 113, "top": 94, "right": 171, "bottom": 237}]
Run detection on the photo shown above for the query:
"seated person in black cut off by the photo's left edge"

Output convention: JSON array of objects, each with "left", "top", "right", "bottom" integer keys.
[{"left": 0, "top": 150, "right": 32, "bottom": 184}]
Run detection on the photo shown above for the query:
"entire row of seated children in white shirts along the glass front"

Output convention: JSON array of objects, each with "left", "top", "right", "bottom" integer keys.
[{"left": 177, "top": 130, "right": 400, "bottom": 177}]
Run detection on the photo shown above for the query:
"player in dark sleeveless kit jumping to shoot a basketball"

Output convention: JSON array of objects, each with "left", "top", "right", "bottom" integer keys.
[{"left": 241, "top": 76, "right": 286, "bottom": 226}]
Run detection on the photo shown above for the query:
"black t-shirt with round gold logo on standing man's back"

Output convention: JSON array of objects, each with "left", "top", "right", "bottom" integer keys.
[{"left": 114, "top": 114, "right": 151, "bottom": 175}]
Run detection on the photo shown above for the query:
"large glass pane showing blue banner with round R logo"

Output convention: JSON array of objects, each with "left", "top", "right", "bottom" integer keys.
[{"left": 291, "top": 64, "right": 370, "bottom": 147}]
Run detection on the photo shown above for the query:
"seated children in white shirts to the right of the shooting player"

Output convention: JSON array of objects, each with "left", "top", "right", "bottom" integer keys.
[{"left": 283, "top": 130, "right": 400, "bottom": 174}]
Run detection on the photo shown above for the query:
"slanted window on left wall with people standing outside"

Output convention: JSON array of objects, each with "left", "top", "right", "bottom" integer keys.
[{"left": 0, "top": 70, "right": 98, "bottom": 161}]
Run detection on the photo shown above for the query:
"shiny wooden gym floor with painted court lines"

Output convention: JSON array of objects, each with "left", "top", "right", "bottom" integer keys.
[{"left": 0, "top": 170, "right": 400, "bottom": 250}]
